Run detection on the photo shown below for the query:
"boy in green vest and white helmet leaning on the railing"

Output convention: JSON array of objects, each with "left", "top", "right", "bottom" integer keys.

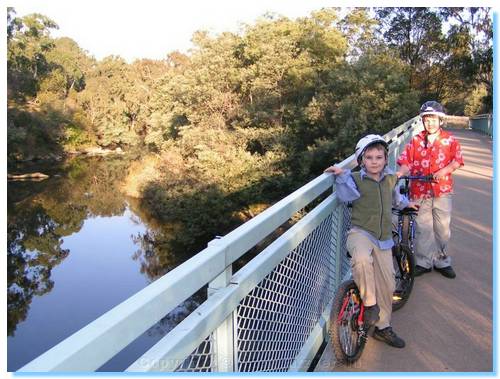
[{"left": 325, "top": 134, "right": 413, "bottom": 348}]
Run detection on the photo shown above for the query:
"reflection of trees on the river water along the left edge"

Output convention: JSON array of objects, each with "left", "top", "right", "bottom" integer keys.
[{"left": 7, "top": 154, "right": 131, "bottom": 335}]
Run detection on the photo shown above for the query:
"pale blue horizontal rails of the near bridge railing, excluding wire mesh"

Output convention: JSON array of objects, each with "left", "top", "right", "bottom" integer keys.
[{"left": 19, "top": 118, "right": 420, "bottom": 372}]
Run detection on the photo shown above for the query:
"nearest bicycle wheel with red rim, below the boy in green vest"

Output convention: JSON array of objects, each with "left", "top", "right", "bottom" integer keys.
[{"left": 330, "top": 280, "right": 367, "bottom": 364}]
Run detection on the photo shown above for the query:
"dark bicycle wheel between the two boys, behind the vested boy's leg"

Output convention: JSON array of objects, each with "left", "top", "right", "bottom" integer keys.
[{"left": 392, "top": 244, "right": 415, "bottom": 311}]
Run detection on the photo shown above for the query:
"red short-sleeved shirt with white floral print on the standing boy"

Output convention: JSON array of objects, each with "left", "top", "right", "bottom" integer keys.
[{"left": 398, "top": 130, "right": 464, "bottom": 199}]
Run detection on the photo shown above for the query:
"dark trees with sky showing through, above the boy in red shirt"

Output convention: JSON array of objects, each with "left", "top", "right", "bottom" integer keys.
[{"left": 376, "top": 7, "right": 493, "bottom": 114}]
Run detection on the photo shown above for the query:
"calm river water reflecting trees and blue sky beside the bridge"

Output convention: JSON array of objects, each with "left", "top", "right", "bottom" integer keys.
[{"left": 7, "top": 158, "right": 204, "bottom": 371}]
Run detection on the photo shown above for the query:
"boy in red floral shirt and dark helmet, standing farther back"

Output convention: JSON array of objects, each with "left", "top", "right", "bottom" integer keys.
[{"left": 397, "top": 101, "right": 464, "bottom": 279}]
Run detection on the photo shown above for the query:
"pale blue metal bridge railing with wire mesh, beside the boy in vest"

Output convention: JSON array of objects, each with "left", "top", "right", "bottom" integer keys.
[{"left": 20, "top": 117, "right": 421, "bottom": 372}]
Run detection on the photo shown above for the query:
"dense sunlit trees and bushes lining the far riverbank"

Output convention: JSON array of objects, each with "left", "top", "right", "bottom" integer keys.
[{"left": 7, "top": 8, "right": 492, "bottom": 248}]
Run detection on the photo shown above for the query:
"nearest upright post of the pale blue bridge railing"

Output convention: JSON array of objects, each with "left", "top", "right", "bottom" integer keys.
[{"left": 208, "top": 237, "right": 235, "bottom": 372}]
